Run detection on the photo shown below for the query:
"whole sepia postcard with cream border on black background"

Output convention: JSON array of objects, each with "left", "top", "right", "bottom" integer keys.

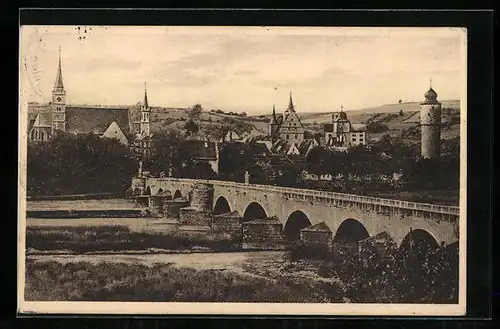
[{"left": 18, "top": 25, "right": 467, "bottom": 316}]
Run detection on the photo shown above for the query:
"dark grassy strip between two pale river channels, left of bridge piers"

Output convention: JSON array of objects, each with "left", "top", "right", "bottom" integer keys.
[{"left": 26, "top": 226, "right": 239, "bottom": 253}]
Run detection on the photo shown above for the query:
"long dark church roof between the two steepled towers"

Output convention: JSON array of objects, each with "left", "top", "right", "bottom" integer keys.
[{"left": 66, "top": 106, "right": 130, "bottom": 135}]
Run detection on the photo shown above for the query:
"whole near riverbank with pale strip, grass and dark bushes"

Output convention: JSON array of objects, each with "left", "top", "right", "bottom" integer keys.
[{"left": 25, "top": 247, "right": 458, "bottom": 303}]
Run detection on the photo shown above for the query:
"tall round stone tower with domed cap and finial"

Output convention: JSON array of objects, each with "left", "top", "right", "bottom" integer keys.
[{"left": 420, "top": 81, "right": 441, "bottom": 159}]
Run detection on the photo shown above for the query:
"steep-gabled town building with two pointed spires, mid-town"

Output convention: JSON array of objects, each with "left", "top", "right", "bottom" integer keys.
[{"left": 268, "top": 92, "right": 305, "bottom": 145}]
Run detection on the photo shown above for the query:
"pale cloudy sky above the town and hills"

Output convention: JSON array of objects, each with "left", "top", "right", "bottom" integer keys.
[{"left": 20, "top": 26, "right": 466, "bottom": 114}]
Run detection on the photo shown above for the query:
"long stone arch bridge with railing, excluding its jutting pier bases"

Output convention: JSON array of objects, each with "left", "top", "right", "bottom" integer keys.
[{"left": 132, "top": 178, "right": 460, "bottom": 247}]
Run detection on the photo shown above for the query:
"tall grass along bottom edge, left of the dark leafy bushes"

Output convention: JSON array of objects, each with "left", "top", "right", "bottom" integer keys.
[{"left": 25, "top": 260, "right": 339, "bottom": 303}]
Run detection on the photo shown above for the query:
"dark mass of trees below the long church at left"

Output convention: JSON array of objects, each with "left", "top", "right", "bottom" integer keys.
[{"left": 27, "top": 133, "right": 137, "bottom": 195}]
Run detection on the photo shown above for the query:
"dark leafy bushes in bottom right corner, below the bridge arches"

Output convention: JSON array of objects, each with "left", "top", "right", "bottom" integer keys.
[{"left": 290, "top": 244, "right": 458, "bottom": 303}]
